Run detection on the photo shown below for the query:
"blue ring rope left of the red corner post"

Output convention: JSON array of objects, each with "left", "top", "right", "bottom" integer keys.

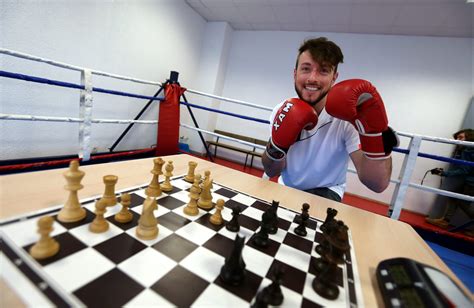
[{"left": 0, "top": 70, "right": 164, "bottom": 101}]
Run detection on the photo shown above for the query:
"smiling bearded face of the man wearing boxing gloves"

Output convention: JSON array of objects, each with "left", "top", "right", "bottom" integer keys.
[{"left": 294, "top": 50, "right": 338, "bottom": 106}]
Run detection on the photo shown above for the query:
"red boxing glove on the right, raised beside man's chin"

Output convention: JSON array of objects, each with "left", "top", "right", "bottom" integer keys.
[{"left": 326, "top": 79, "right": 399, "bottom": 159}]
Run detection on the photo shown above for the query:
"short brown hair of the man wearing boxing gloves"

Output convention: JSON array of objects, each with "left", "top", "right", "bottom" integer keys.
[{"left": 295, "top": 37, "right": 344, "bottom": 72}]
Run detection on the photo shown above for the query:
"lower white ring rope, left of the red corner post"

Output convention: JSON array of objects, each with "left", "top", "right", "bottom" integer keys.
[{"left": 0, "top": 113, "right": 158, "bottom": 124}]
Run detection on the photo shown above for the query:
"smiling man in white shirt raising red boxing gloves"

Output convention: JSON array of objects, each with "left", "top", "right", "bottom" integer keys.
[{"left": 262, "top": 38, "right": 398, "bottom": 201}]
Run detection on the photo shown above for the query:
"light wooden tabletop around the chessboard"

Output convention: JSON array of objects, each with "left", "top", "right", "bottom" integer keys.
[{"left": 0, "top": 154, "right": 471, "bottom": 307}]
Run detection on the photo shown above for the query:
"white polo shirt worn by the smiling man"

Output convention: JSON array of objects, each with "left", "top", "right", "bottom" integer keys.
[{"left": 270, "top": 102, "right": 360, "bottom": 198}]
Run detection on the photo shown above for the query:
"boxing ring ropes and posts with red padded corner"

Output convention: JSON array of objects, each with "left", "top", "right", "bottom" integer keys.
[{"left": 0, "top": 49, "right": 474, "bottom": 220}]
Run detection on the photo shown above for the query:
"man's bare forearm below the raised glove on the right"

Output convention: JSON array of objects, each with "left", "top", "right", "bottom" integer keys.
[{"left": 350, "top": 150, "right": 392, "bottom": 193}]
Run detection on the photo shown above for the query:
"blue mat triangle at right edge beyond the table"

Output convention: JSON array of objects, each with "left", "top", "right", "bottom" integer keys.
[{"left": 426, "top": 241, "right": 474, "bottom": 292}]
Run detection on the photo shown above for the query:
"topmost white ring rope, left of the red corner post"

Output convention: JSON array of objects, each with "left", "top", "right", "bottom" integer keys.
[{"left": 0, "top": 48, "right": 162, "bottom": 87}]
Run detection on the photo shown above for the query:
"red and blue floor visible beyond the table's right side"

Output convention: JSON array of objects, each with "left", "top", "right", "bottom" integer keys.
[{"left": 196, "top": 157, "right": 474, "bottom": 292}]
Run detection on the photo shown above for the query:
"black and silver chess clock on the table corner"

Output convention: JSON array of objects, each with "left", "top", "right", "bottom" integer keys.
[{"left": 376, "top": 258, "right": 472, "bottom": 308}]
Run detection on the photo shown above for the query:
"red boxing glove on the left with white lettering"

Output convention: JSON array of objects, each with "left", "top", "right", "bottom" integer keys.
[{"left": 266, "top": 98, "right": 318, "bottom": 160}]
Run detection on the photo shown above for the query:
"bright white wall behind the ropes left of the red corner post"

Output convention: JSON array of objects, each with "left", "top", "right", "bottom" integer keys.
[{"left": 0, "top": 0, "right": 206, "bottom": 160}]
